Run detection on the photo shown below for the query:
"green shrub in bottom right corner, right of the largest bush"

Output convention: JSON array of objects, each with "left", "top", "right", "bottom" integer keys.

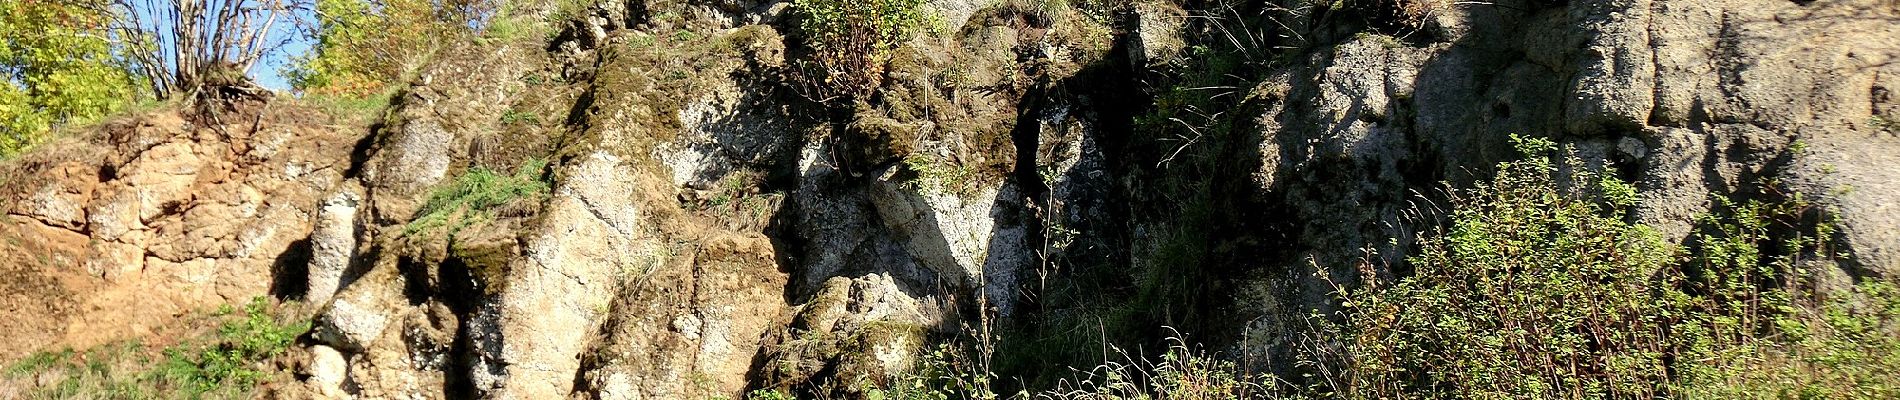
[{"left": 1680, "top": 195, "right": 1900, "bottom": 398}]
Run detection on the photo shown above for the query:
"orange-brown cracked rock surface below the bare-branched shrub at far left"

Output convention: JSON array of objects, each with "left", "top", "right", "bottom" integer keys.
[{"left": 0, "top": 108, "right": 357, "bottom": 358}]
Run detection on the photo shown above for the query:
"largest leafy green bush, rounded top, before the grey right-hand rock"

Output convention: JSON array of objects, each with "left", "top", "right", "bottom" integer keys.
[{"left": 1332, "top": 135, "right": 1691, "bottom": 398}]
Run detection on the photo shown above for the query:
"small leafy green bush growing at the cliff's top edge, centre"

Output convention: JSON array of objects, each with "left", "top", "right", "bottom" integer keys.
[{"left": 792, "top": 0, "right": 929, "bottom": 100}]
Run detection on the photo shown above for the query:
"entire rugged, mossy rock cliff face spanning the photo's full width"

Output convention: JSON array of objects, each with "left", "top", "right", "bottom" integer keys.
[{"left": 0, "top": 0, "right": 1900, "bottom": 398}]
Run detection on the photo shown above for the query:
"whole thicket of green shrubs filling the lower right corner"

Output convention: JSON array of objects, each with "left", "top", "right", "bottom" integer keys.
[{"left": 1307, "top": 135, "right": 1900, "bottom": 398}]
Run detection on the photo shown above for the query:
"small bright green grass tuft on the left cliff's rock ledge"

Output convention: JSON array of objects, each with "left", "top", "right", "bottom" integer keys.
[{"left": 403, "top": 159, "right": 549, "bottom": 235}]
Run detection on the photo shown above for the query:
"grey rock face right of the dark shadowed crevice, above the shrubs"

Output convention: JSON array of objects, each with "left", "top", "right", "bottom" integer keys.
[{"left": 1250, "top": 0, "right": 1900, "bottom": 363}]
